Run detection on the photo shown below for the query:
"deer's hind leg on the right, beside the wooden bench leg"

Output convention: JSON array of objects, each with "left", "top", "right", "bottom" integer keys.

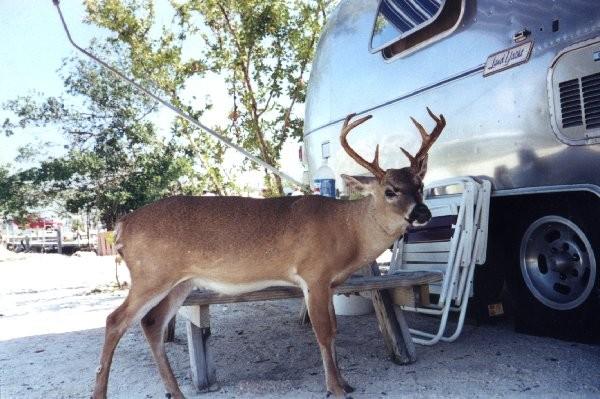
[{"left": 142, "top": 280, "right": 194, "bottom": 399}]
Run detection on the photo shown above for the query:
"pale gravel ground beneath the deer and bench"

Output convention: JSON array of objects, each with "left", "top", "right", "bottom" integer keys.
[{"left": 0, "top": 249, "right": 600, "bottom": 399}]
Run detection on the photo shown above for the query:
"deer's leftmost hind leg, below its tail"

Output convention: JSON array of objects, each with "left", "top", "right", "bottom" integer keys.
[{"left": 92, "top": 276, "right": 173, "bottom": 399}]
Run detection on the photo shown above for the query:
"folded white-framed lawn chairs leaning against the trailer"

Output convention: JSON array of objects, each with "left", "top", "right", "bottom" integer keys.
[{"left": 389, "top": 177, "right": 491, "bottom": 345}]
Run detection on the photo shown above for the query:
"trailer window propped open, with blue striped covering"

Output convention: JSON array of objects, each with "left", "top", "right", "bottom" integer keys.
[{"left": 370, "top": 0, "right": 465, "bottom": 58}]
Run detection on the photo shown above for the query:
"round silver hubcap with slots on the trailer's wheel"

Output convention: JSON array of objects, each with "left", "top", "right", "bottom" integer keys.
[{"left": 520, "top": 216, "right": 596, "bottom": 310}]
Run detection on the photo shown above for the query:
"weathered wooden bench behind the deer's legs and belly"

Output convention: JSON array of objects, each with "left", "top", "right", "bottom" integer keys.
[{"left": 179, "top": 264, "right": 442, "bottom": 391}]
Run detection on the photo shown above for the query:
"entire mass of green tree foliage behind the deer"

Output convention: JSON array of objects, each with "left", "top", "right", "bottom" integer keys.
[{"left": 0, "top": 0, "right": 332, "bottom": 229}]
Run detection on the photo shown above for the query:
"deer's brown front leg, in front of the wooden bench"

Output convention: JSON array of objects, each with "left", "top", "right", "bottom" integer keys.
[{"left": 306, "top": 286, "right": 346, "bottom": 398}]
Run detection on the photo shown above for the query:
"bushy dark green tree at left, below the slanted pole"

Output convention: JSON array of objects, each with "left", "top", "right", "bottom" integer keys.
[{"left": 3, "top": 44, "right": 213, "bottom": 229}]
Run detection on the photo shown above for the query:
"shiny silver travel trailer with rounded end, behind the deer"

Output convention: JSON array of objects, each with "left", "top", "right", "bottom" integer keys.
[{"left": 304, "top": 0, "right": 600, "bottom": 340}]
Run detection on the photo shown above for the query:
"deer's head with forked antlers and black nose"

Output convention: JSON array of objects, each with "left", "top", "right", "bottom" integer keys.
[{"left": 340, "top": 108, "right": 446, "bottom": 225}]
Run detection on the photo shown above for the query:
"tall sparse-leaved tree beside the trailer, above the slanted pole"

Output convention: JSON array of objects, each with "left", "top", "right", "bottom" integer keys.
[{"left": 86, "top": 0, "right": 332, "bottom": 195}]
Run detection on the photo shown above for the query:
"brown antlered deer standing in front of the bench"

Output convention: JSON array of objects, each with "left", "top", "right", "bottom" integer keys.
[{"left": 93, "top": 108, "right": 446, "bottom": 399}]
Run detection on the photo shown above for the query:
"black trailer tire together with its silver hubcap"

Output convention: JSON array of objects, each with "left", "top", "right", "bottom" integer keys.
[{"left": 507, "top": 212, "right": 600, "bottom": 342}]
